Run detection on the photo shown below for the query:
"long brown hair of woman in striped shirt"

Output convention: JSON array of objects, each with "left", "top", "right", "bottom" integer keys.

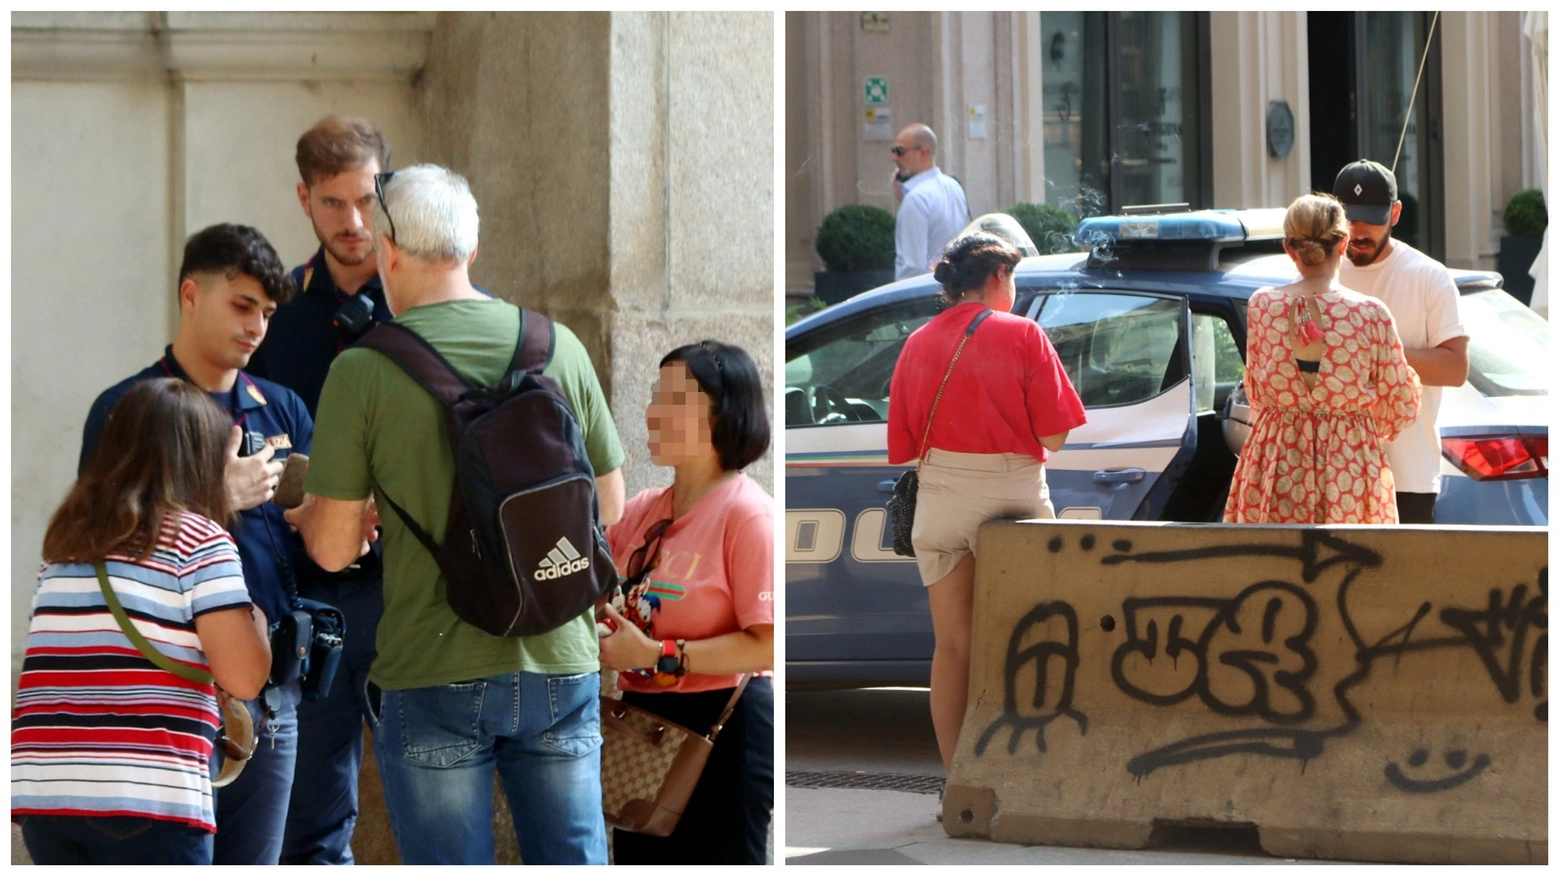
[{"left": 44, "top": 378, "right": 231, "bottom": 563}]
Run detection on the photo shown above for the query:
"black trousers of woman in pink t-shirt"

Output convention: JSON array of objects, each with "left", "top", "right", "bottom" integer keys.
[{"left": 612, "top": 677, "right": 775, "bottom": 865}]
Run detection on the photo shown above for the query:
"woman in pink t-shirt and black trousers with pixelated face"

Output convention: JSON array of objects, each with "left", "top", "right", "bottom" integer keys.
[{"left": 601, "top": 340, "right": 774, "bottom": 865}]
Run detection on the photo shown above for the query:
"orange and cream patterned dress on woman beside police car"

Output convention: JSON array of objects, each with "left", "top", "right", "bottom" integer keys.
[{"left": 1225, "top": 289, "right": 1420, "bottom": 524}]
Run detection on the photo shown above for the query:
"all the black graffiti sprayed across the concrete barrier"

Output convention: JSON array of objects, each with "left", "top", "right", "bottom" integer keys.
[{"left": 975, "top": 531, "right": 1549, "bottom": 793}]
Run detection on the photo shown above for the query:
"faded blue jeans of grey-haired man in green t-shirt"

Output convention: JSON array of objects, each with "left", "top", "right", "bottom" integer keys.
[{"left": 370, "top": 673, "right": 607, "bottom": 865}]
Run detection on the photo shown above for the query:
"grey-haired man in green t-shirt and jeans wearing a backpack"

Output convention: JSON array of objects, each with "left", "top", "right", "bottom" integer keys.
[{"left": 289, "top": 164, "right": 624, "bottom": 865}]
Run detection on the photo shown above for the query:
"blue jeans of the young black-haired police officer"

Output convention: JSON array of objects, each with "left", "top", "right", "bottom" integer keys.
[{"left": 212, "top": 682, "right": 301, "bottom": 865}]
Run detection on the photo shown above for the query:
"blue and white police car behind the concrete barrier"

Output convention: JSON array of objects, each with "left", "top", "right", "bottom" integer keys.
[{"left": 785, "top": 209, "right": 1549, "bottom": 688}]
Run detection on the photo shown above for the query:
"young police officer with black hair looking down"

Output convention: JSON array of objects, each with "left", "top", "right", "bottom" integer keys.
[{"left": 81, "top": 225, "right": 314, "bottom": 865}]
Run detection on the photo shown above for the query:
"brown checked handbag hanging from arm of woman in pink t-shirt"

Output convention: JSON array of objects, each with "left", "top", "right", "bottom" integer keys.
[{"left": 601, "top": 673, "right": 752, "bottom": 838}]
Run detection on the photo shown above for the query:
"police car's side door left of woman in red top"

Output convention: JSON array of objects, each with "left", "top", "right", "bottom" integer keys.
[{"left": 785, "top": 287, "right": 938, "bottom": 683}]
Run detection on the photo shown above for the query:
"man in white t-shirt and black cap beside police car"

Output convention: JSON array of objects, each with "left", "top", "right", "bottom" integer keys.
[{"left": 1332, "top": 161, "right": 1468, "bottom": 524}]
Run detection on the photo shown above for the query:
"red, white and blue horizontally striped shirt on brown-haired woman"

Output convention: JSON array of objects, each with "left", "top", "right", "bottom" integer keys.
[{"left": 11, "top": 512, "right": 251, "bottom": 832}]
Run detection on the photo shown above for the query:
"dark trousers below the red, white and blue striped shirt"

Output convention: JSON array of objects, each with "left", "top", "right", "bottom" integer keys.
[{"left": 17, "top": 816, "right": 212, "bottom": 865}]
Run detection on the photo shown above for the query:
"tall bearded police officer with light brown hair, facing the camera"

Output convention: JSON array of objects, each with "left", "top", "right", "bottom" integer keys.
[{"left": 250, "top": 115, "right": 390, "bottom": 865}]
